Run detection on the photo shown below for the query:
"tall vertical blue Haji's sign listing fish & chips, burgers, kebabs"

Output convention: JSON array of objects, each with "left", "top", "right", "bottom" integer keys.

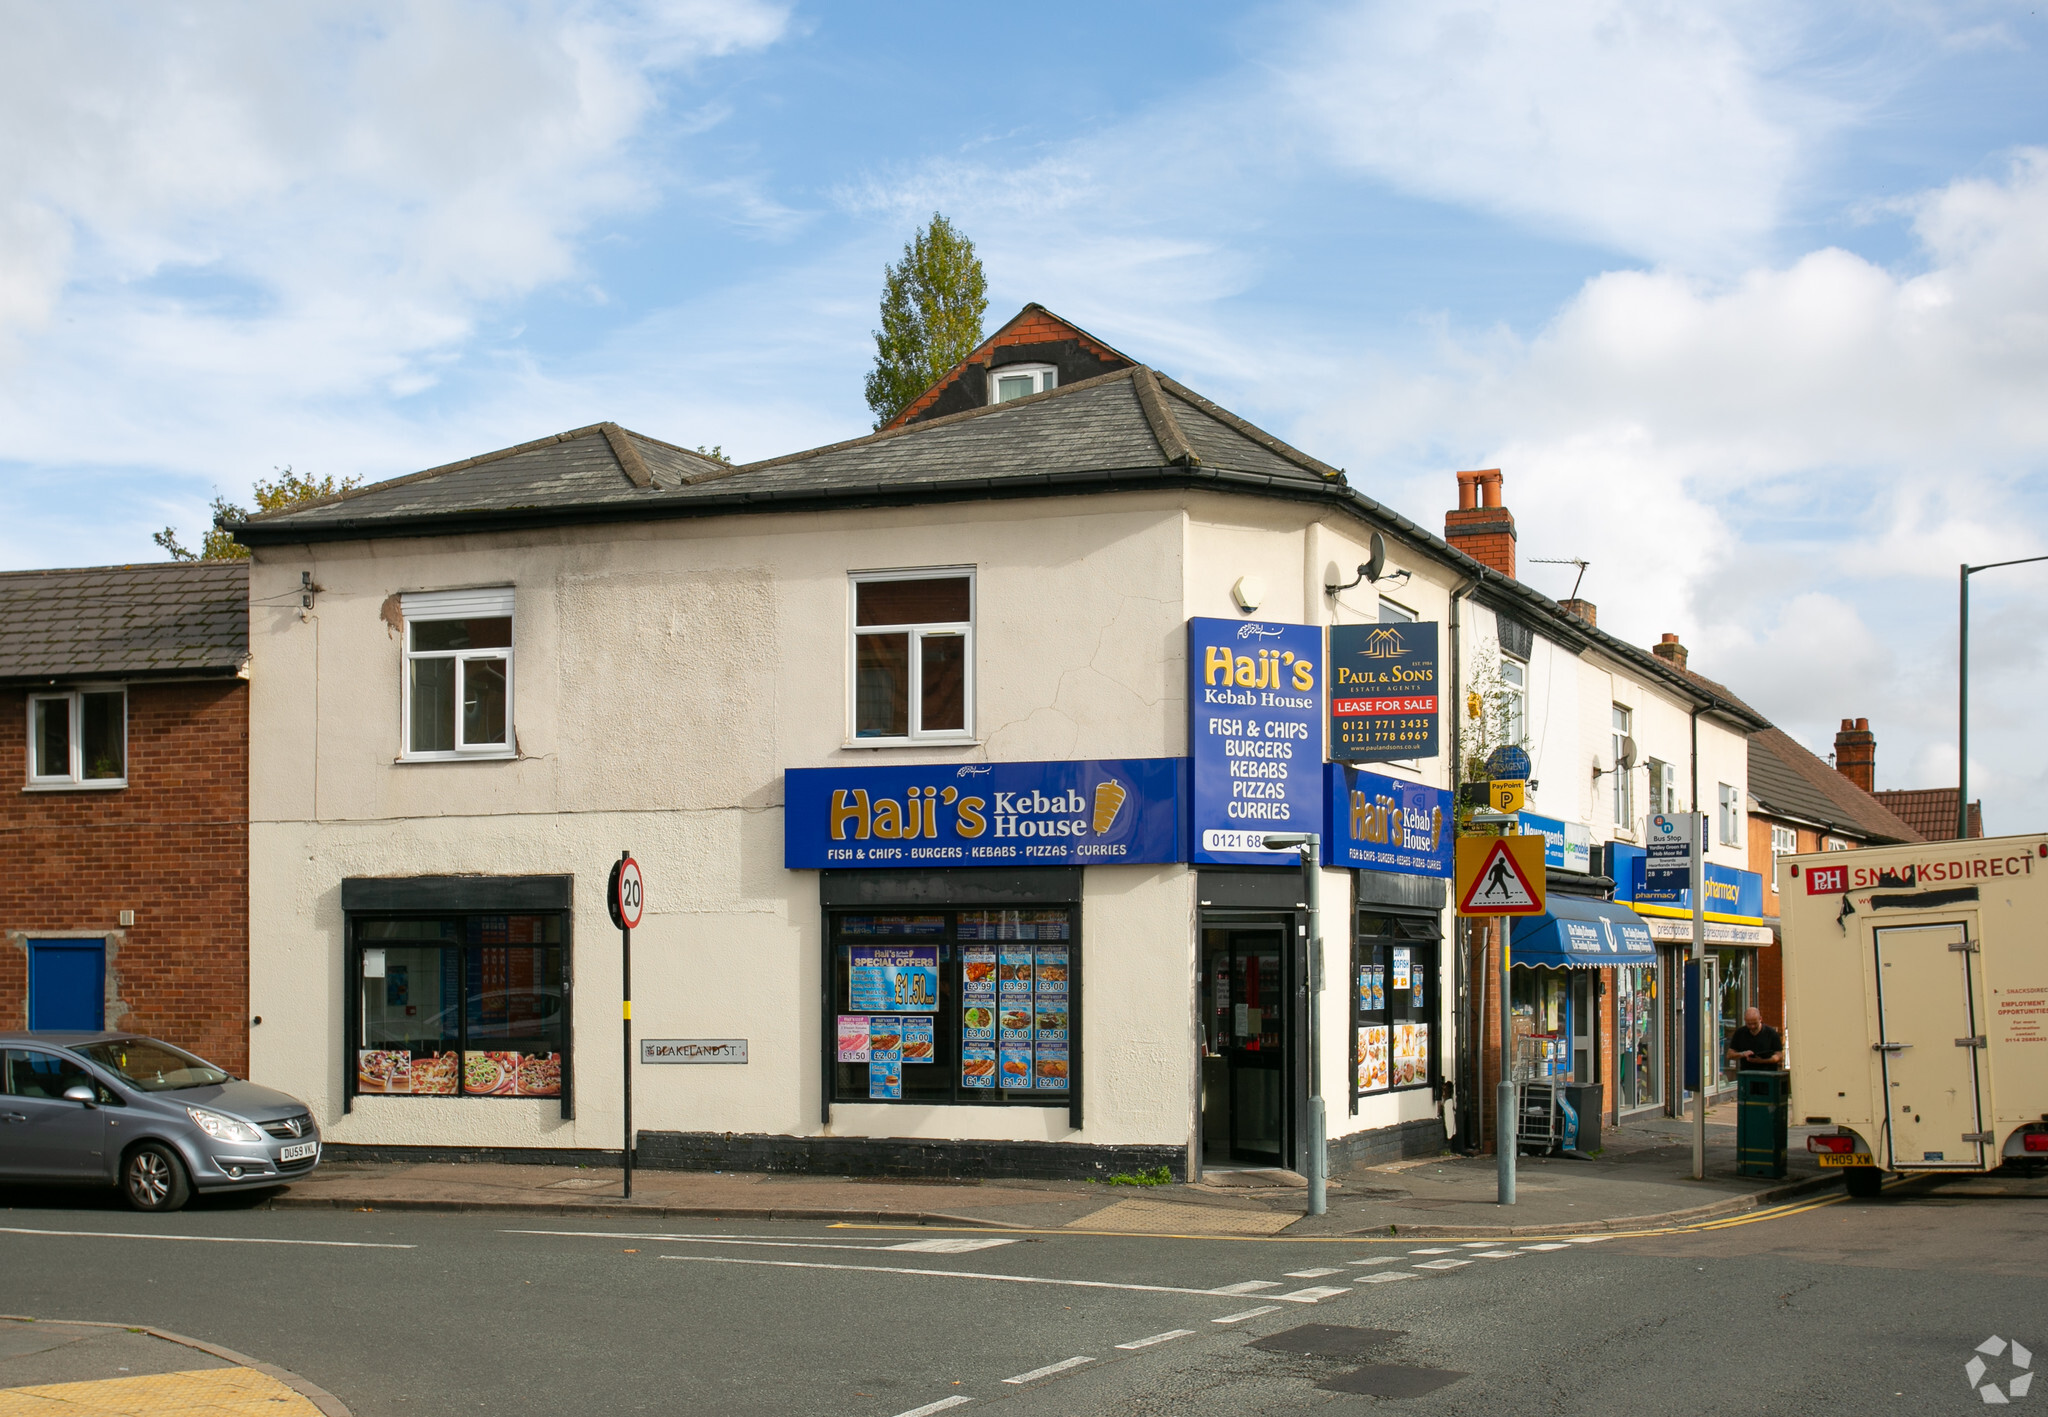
[{"left": 1188, "top": 618, "right": 1323, "bottom": 866}]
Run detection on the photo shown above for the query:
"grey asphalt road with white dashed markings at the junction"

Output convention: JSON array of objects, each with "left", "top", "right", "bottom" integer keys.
[{"left": 0, "top": 1194, "right": 2048, "bottom": 1417}]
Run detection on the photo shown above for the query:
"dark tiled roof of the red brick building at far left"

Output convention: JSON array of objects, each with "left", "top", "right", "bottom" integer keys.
[{"left": 0, "top": 561, "right": 250, "bottom": 684}]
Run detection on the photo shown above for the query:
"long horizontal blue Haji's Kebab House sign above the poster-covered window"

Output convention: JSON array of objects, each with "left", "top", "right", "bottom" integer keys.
[{"left": 782, "top": 758, "right": 1188, "bottom": 870}]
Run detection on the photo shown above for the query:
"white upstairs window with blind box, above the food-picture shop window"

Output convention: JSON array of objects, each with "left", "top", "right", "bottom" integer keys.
[{"left": 399, "top": 586, "right": 518, "bottom": 762}]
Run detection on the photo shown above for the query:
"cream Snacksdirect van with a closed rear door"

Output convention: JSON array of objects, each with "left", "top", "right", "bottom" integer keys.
[{"left": 1778, "top": 835, "right": 2048, "bottom": 1196}]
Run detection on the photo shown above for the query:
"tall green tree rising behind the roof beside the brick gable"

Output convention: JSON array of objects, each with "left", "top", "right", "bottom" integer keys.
[{"left": 866, "top": 211, "right": 989, "bottom": 428}]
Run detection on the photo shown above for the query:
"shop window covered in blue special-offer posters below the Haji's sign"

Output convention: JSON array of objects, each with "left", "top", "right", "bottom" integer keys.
[{"left": 829, "top": 907, "right": 1081, "bottom": 1106}]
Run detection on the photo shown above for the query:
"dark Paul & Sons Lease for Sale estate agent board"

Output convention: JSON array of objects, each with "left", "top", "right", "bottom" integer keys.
[{"left": 1329, "top": 620, "right": 1438, "bottom": 762}]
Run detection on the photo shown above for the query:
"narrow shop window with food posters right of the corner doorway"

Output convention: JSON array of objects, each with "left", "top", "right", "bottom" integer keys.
[{"left": 1352, "top": 911, "right": 1440, "bottom": 1110}]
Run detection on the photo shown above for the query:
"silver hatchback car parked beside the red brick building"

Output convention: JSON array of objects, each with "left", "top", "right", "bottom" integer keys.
[{"left": 0, "top": 1032, "right": 319, "bottom": 1210}]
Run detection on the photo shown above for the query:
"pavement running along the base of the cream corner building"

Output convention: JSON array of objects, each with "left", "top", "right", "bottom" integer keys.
[{"left": 268, "top": 1110, "right": 1833, "bottom": 1235}]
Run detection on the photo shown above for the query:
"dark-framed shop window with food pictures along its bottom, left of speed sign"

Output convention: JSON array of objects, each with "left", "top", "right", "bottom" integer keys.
[{"left": 348, "top": 913, "right": 569, "bottom": 1098}]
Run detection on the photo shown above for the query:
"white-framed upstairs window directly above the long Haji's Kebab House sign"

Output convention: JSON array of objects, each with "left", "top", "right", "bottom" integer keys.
[{"left": 850, "top": 567, "right": 975, "bottom": 745}]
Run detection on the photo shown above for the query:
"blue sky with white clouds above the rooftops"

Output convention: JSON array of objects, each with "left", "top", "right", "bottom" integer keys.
[{"left": 0, "top": 0, "right": 2048, "bottom": 831}]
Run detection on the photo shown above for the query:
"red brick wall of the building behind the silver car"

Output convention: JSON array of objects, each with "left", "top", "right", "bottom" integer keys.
[{"left": 0, "top": 680, "right": 250, "bottom": 1075}]
